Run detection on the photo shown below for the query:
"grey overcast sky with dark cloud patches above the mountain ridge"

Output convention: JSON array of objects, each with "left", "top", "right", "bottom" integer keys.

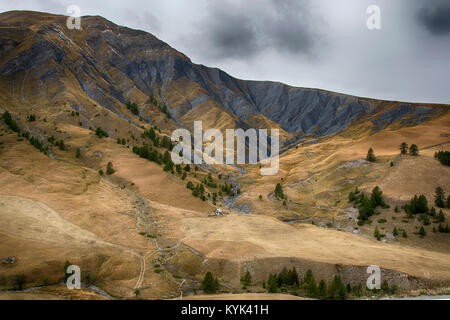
[{"left": 0, "top": 0, "right": 450, "bottom": 103}]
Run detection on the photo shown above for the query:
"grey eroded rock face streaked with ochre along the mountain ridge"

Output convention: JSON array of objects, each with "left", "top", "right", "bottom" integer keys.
[{"left": 0, "top": 12, "right": 443, "bottom": 141}]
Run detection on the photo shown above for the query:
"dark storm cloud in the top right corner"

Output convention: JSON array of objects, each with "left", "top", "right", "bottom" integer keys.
[{"left": 417, "top": 4, "right": 450, "bottom": 36}]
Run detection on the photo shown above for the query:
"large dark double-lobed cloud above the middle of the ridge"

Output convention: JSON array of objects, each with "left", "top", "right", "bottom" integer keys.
[{"left": 190, "top": 0, "right": 319, "bottom": 59}]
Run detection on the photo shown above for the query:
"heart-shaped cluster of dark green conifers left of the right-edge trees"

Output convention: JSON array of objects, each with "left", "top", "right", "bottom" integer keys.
[{"left": 348, "top": 186, "right": 390, "bottom": 225}]
